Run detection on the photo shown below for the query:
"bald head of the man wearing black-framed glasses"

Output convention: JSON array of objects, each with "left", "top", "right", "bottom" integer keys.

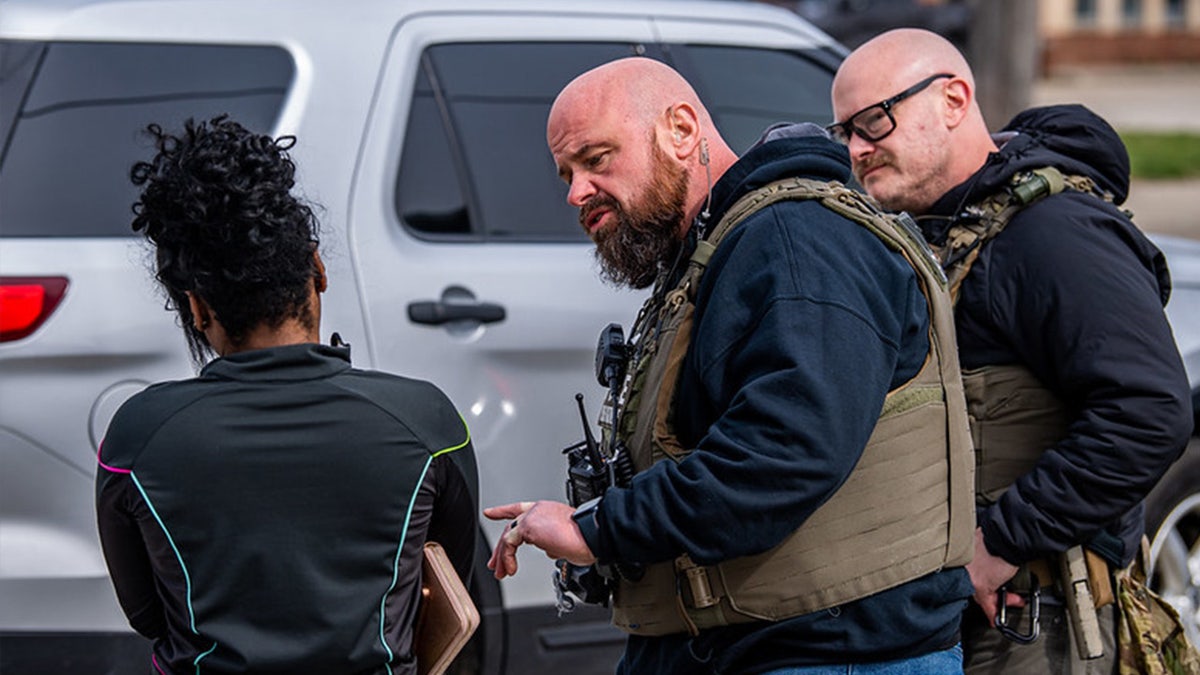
[{"left": 832, "top": 28, "right": 996, "bottom": 214}]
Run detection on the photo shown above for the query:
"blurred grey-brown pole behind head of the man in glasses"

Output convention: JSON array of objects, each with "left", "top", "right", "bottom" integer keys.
[{"left": 966, "top": 0, "right": 1042, "bottom": 131}]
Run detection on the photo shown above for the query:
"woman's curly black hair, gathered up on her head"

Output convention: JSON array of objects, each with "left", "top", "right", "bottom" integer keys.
[{"left": 130, "top": 115, "right": 320, "bottom": 364}]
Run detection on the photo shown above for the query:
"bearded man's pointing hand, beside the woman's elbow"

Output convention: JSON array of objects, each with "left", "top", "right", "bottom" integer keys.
[{"left": 484, "top": 501, "right": 596, "bottom": 579}]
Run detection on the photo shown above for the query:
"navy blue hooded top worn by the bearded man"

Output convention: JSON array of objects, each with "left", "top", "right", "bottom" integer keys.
[{"left": 581, "top": 128, "right": 971, "bottom": 675}]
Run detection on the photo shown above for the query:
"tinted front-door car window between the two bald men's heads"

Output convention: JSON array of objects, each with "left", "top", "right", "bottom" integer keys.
[{"left": 672, "top": 44, "right": 836, "bottom": 153}]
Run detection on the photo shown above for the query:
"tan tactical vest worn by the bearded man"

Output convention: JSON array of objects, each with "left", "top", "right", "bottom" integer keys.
[{"left": 604, "top": 179, "right": 974, "bottom": 635}]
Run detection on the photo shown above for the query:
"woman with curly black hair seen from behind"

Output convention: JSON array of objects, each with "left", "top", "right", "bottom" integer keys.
[{"left": 96, "top": 117, "right": 478, "bottom": 675}]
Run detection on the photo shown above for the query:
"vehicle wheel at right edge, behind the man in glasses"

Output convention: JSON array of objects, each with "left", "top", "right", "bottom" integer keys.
[{"left": 1146, "top": 437, "right": 1200, "bottom": 644}]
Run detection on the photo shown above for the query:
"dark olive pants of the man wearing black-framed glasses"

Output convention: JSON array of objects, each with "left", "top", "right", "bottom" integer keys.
[{"left": 962, "top": 602, "right": 1117, "bottom": 675}]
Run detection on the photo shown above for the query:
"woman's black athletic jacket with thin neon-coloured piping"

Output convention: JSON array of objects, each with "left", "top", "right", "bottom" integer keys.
[{"left": 96, "top": 345, "right": 478, "bottom": 675}]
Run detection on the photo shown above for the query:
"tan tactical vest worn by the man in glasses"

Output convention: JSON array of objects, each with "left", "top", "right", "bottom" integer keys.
[{"left": 937, "top": 167, "right": 1112, "bottom": 504}]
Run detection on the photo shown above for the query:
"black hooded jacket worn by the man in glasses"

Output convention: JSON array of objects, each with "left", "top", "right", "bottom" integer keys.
[{"left": 918, "top": 106, "right": 1192, "bottom": 565}]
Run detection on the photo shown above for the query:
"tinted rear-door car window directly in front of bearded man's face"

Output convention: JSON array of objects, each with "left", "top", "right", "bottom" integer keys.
[{"left": 396, "top": 42, "right": 642, "bottom": 241}]
